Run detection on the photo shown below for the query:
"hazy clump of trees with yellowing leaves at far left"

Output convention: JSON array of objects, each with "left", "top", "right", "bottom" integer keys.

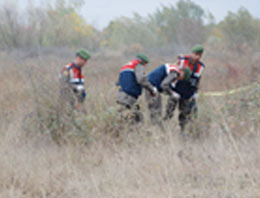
[{"left": 0, "top": 0, "right": 100, "bottom": 50}]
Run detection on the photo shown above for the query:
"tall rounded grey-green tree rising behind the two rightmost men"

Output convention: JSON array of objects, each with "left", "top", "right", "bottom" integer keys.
[{"left": 150, "top": 0, "right": 206, "bottom": 49}]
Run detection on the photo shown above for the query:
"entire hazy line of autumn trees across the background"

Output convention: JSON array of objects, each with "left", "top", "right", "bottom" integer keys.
[{"left": 0, "top": 0, "right": 260, "bottom": 55}]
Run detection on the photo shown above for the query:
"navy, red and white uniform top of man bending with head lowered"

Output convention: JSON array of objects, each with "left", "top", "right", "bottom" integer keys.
[{"left": 148, "top": 63, "right": 180, "bottom": 94}]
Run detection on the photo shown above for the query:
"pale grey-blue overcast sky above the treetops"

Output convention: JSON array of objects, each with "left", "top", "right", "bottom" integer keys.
[{"left": 81, "top": 0, "right": 260, "bottom": 29}]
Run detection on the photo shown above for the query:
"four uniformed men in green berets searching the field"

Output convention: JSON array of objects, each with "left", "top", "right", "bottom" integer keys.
[{"left": 60, "top": 45, "right": 205, "bottom": 130}]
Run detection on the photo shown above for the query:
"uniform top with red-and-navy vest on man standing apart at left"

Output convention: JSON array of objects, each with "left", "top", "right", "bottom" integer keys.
[{"left": 60, "top": 63, "right": 86, "bottom": 102}]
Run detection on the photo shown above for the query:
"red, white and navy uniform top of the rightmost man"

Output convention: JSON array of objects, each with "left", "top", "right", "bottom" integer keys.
[{"left": 172, "top": 55, "right": 205, "bottom": 99}]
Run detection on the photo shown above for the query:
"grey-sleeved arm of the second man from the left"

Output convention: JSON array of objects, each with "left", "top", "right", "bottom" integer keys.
[{"left": 135, "top": 64, "right": 155, "bottom": 93}]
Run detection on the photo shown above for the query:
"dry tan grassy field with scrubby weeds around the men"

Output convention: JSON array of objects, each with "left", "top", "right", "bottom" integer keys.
[{"left": 0, "top": 52, "right": 260, "bottom": 198}]
